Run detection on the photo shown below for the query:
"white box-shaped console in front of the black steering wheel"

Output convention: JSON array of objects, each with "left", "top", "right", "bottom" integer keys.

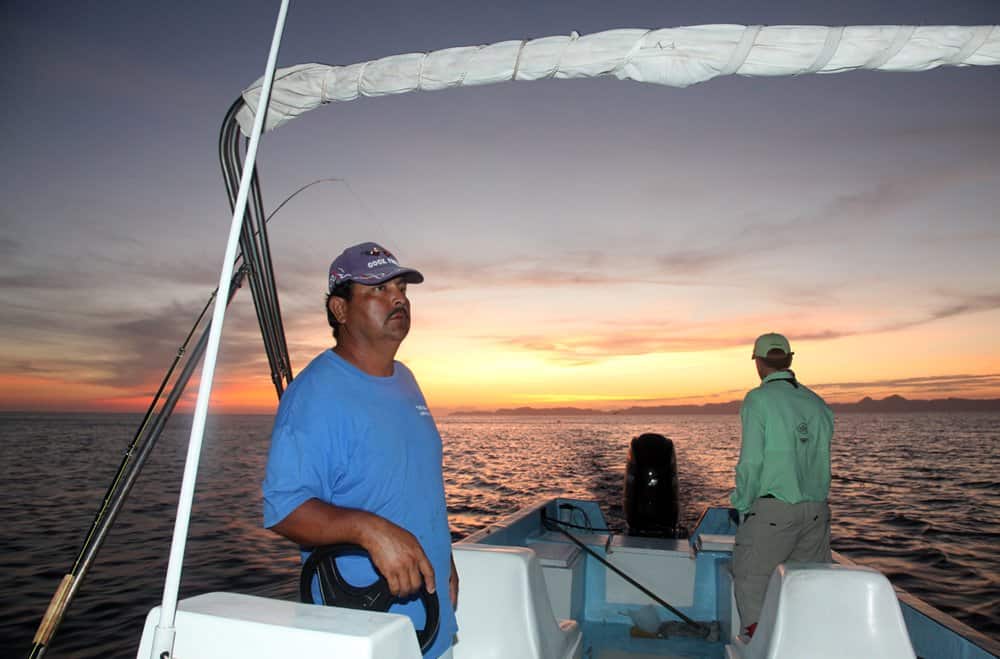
[{"left": 136, "top": 593, "right": 421, "bottom": 659}]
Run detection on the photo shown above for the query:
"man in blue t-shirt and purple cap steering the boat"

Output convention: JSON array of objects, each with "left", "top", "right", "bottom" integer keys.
[{"left": 263, "top": 243, "right": 458, "bottom": 658}]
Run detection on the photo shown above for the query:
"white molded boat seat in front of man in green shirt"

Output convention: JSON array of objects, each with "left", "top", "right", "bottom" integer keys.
[{"left": 726, "top": 563, "right": 916, "bottom": 659}]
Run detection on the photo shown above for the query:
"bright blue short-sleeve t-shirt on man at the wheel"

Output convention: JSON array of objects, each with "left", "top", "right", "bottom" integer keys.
[{"left": 263, "top": 350, "right": 458, "bottom": 657}]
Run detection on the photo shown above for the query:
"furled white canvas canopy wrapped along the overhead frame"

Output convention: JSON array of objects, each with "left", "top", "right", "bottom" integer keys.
[{"left": 237, "top": 25, "right": 1000, "bottom": 134}]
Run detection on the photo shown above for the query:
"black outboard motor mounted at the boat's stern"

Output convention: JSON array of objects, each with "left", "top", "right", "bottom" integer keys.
[{"left": 625, "top": 433, "right": 680, "bottom": 538}]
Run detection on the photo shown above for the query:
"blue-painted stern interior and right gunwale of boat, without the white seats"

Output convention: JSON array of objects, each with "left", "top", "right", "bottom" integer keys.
[{"left": 462, "top": 499, "right": 1000, "bottom": 659}]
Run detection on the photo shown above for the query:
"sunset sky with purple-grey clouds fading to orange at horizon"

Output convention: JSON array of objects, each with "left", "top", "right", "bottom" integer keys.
[{"left": 0, "top": 0, "right": 1000, "bottom": 412}]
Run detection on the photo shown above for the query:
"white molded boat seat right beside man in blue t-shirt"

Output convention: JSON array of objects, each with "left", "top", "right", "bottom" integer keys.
[{"left": 452, "top": 543, "right": 583, "bottom": 659}]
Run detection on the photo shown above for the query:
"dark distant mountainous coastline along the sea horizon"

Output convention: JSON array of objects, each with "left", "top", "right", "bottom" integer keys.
[{"left": 448, "top": 395, "right": 1000, "bottom": 417}]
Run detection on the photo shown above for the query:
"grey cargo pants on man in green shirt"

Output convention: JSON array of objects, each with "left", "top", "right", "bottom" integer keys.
[{"left": 733, "top": 498, "right": 832, "bottom": 627}]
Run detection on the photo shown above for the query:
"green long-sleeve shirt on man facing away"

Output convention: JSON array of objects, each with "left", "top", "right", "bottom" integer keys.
[{"left": 729, "top": 371, "right": 833, "bottom": 513}]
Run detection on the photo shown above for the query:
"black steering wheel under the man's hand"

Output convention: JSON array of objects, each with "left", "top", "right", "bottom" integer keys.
[{"left": 299, "top": 545, "right": 440, "bottom": 653}]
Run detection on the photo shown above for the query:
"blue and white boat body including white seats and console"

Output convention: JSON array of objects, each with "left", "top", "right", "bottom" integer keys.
[{"left": 137, "top": 499, "right": 1000, "bottom": 659}]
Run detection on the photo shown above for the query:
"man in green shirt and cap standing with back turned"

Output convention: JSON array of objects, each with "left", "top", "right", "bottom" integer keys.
[{"left": 730, "top": 334, "right": 833, "bottom": 636}]
